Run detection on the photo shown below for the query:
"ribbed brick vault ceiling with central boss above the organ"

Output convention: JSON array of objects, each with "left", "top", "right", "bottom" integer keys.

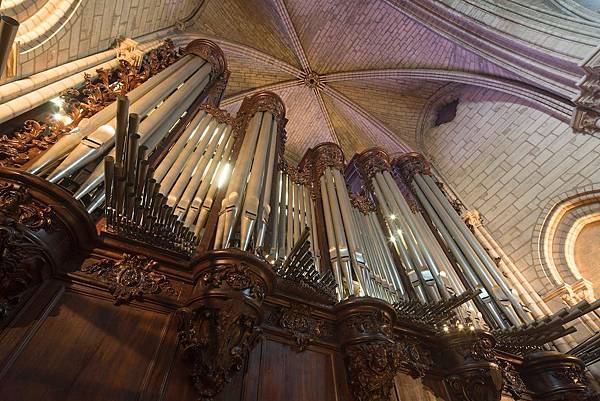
[{"left": 193, "top": 0, "right": 514, "bottom": 160}]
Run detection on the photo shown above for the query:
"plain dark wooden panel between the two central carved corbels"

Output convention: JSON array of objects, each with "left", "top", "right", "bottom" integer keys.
[{"left": 244, "top": 339, "right": 346, "bottom": 401}]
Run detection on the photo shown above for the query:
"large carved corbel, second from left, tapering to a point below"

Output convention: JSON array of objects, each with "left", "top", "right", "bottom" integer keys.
[{"left": 178, "top": 251, "right": 274, "bottom": 400}]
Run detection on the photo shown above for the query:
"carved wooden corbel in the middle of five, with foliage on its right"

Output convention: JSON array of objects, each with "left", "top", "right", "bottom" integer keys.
[{"left": 336, "top": 297, "right": 428, "bottom": 401}]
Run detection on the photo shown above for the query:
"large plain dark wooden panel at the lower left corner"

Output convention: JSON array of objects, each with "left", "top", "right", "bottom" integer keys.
[{"left": 0, "top": 293, "right": 167, "bottom": 401}]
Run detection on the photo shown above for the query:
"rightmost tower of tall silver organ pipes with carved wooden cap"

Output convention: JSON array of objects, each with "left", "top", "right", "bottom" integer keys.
[{"left": 393, "top": 154, "right": 531, "bottom": 327}]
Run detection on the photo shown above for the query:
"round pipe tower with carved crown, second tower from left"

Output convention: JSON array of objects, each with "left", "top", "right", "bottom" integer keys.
[{"left": 214, "top": 92, "right": 287, "bottom": 252}]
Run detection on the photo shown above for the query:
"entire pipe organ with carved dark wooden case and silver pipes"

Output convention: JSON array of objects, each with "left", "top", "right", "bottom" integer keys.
[{"left": 0, "top": 40, "right": 598, "bottom": 401}]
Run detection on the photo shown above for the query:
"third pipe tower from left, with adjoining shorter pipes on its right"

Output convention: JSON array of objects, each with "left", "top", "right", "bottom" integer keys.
[{"left": 301, "top": 143, "right": 404, "bottom": 302}]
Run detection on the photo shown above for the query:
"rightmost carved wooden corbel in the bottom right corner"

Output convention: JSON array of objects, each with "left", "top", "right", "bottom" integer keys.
[{"left": 521, "top": 351, "right": 599, "bottom": 401}]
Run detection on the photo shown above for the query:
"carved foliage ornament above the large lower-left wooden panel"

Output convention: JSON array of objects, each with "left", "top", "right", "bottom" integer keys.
[{"left": 81, "top": 254, "right": 175, "bottom": 305}]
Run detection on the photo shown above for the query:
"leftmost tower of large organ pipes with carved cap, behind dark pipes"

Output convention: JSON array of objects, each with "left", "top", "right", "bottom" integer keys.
[{"left": 25, "top": 40, "right": 226, "bottom": 208}]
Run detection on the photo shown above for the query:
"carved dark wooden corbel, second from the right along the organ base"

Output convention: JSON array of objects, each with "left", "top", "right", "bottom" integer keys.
[{"left": 440, "top": 331, "right": 504, "bottom": 401}]
